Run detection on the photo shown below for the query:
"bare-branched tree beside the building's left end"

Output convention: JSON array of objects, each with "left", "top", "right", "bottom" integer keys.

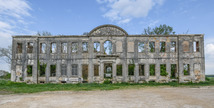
[{"left": 0, "top": 45, "right": 12, "bottom": 66}]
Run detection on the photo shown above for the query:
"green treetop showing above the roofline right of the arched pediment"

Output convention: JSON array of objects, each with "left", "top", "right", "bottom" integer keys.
[{"left": 143, "top": 24, "right": 175, "bottom": 35}]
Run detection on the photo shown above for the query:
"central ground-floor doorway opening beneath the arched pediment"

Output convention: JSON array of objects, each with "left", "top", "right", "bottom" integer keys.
[{"left": 104, "top": 63, "right": 112, "bottom": 79}]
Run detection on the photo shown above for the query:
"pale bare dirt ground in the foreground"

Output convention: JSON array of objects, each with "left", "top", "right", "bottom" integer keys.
[{"left": 0, "top": 87, "right": 214, "bottom": 108}]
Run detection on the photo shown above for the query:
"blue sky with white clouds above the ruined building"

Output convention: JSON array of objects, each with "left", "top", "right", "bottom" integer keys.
[{"left": 0, "top": 0, "right": 214, "bottom": 74}]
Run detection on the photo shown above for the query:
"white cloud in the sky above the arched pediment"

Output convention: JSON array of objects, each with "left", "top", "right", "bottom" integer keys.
[{"left": 97, "top": 0, "right": 164, "bottom": 23}]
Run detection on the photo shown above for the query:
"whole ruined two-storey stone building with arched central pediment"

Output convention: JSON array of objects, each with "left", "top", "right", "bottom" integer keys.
[{"left": 11, "top": 25, "right": 205, "bottom": 83}]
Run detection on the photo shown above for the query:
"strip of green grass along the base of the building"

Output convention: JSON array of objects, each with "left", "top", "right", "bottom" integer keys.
[{"left": 0, "top": 77, "right": 214, "bottom": 94}]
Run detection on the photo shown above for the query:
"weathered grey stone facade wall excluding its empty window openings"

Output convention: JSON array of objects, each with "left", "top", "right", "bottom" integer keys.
[{"left": 11, "top": 25, "right": 205, "bottom": 83}]
